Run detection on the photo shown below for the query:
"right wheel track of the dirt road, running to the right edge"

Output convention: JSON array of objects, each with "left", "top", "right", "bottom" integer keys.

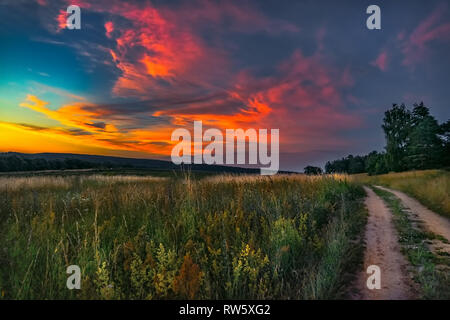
[{"left": 376, "top": 186, "right": 450, "bottom": 241}]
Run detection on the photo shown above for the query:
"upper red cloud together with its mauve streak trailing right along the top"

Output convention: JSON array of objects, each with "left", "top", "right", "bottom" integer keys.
[{"left": 54, "top": 0, "right": 298, "bottom": 98}]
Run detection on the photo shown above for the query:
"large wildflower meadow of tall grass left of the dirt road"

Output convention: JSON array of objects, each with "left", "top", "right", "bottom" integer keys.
[{"left": 0, "top": 174, "right": 366, "bottom": 299}]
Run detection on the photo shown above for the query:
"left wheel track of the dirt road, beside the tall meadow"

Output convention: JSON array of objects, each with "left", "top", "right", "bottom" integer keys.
[{"left": 352, "top": 187, "right": 416, "bottom": 300}]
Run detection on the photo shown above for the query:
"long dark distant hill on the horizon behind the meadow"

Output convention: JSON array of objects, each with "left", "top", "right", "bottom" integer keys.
[{"left": 0, "top": 152, "right": 268, "bottom": 173}]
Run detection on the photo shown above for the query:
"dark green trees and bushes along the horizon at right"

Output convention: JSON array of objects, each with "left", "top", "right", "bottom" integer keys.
[{"left": 322, "top": 102, "right": 450, "bottom": 175}]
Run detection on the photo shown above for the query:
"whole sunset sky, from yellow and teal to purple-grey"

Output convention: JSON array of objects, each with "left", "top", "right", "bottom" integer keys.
[{"left": 0, "top": 0, "right": 450, "bottom": 171}]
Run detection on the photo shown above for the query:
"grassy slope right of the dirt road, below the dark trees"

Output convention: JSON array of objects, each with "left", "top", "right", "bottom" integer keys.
[{"left": 350, "top": 170, "right": 450, "bottom": 218}]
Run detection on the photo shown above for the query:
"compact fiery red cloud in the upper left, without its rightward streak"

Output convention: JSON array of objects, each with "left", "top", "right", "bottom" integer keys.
[{"left": 85, "top": 2, "right": 227, "bottom": 98}]
